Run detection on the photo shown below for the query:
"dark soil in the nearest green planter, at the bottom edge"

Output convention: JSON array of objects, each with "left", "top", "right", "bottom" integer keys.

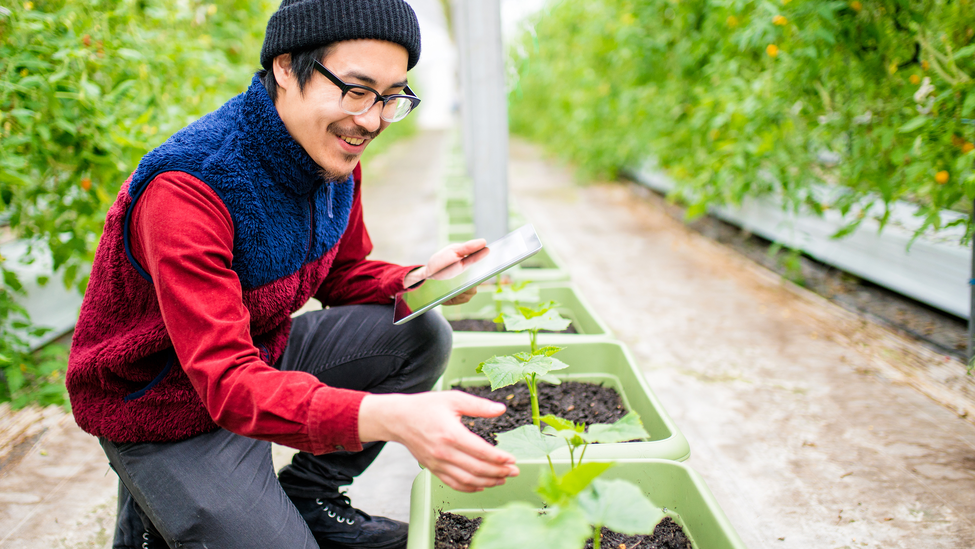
[{"left": 433, "top": 512, "right": 693, "bottom": 549}]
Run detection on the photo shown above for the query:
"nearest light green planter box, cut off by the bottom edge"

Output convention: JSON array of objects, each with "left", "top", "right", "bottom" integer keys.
[{"left": 407, "top": 458, "right": 745, "bottom": 549}]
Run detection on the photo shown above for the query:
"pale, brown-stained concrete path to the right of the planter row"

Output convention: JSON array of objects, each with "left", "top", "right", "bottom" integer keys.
[{"left": 510, "top": 138, "right": 975, "bottom": 549}]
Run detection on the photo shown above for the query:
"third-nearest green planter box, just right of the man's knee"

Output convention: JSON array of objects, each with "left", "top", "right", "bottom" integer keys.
[{"left": 441, "top": 282, "right": 613, "bottom": 343}]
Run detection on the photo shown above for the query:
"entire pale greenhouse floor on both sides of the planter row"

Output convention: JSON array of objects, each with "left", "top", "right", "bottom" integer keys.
[{"left": 0, "top": 132, "right": 975, "bottom": 549}]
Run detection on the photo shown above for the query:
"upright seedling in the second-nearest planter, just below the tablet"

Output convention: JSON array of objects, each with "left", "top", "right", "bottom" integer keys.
[{"left": 477, "top": 301, "right": 572, "bottom": 428}]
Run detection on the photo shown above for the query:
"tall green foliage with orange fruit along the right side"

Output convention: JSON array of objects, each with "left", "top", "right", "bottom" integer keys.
[{"left": 510, "top": 0, "right": 975, "bottom": 240}]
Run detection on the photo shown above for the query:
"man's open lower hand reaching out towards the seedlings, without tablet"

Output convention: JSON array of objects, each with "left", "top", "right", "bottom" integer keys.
[{"left": 359, "top": 391, "right": 518, "bottom": 492}]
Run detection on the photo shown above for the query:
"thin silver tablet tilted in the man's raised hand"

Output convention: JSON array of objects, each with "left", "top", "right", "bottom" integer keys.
[{"left": 393, "top": 224, "right": 542, "bottom": 324}]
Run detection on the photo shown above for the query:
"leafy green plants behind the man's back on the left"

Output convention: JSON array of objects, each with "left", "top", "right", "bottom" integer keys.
[{"left": 0, "top": 0, "right": 278, "bottom": 406}]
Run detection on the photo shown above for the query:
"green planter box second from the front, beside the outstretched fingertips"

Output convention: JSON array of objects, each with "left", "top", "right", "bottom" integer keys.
[{"left": 434, "top": 334, "right": 691, "bottom": 462}]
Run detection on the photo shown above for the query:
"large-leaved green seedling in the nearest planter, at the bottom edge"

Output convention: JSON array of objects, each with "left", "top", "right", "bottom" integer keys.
[{"left": 471, "top": 412, "right": 664, "bottom": 549}]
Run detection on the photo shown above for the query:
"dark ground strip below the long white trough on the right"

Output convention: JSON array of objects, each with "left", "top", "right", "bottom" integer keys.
[{"left": 631, "top": 178, "right": 968, "bottom": 362}]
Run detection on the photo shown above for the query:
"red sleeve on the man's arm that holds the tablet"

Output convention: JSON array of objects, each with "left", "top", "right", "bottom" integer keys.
[{"left": 315, "top": 165, "right": 422, "bottom": 306}]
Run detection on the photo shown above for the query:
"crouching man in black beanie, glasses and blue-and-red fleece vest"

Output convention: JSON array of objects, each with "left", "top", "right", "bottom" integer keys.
[{"left": 67, "top": 0, "right": 518, "bottom": 549}]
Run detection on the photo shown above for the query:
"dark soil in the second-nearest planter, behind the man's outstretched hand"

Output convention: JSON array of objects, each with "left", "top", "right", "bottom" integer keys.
[{"left": 451, "top": 381, "right": 626, "bottom": 444}]
